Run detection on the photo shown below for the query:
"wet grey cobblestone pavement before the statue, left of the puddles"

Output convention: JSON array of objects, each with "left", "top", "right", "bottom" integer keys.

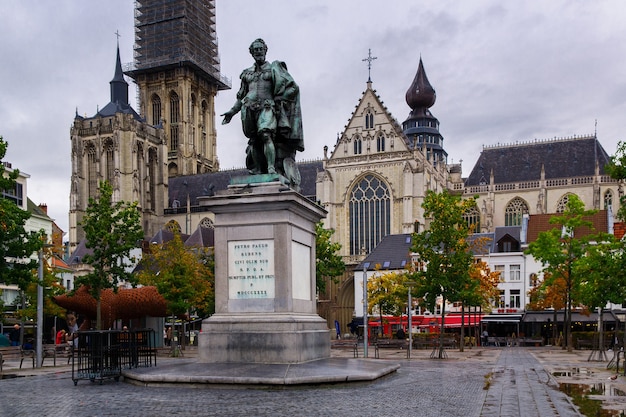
[{"left": 0, "top": 348, "right": 624, "bottom": 417}]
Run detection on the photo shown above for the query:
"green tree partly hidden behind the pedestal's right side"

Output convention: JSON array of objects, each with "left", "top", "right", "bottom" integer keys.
[{"left": 315, "top": 222, "right": 346, "bottom": 293}]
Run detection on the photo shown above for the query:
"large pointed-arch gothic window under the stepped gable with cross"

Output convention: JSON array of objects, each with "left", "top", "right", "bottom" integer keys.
[{"left": 349, "top": 175, "right": 391, "bottom": 255}]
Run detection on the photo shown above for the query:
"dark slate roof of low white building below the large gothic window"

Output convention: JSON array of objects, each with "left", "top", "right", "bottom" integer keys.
[{"left": 355, "top": 233, "right": 411, "bottom": 271}]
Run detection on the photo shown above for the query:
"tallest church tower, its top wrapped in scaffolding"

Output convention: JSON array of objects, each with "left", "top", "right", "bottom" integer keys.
[{"left": 126, "top": 0, "right": 230, "bottom": 177}]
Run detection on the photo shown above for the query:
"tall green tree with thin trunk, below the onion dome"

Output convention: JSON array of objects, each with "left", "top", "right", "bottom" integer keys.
[{"left": 404, "top": 191, "right": 475, "bottom": 359}]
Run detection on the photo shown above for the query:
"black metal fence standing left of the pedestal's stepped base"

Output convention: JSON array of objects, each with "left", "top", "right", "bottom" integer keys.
[{"left": 72, "top": 329, "right": 156, "bottom": 385}]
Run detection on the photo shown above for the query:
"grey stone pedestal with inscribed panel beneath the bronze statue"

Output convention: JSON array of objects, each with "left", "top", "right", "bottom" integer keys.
[{"left": 198, "top": 182, "right": 330, "bottom": 363}]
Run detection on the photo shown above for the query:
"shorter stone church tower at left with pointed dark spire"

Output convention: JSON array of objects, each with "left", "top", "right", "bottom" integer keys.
[{"left": 69, "top": 45, "right": 168, "bottom": 251}]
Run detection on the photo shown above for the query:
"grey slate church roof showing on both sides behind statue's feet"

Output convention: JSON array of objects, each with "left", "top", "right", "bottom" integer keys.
[{"left": 168, "top": 160, "right": 323, "bottom": 208}]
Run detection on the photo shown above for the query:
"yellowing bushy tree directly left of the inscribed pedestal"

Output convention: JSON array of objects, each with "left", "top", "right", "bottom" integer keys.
[{"left": 139, "top": 233, "right": 215, "bottom": 317}]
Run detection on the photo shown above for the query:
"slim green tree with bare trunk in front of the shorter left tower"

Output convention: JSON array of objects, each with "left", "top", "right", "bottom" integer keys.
[{"left": 76, "top": 181, "right": 143, "bottom": 330}]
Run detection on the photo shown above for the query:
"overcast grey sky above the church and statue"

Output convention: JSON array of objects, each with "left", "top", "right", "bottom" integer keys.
[{"left": 0, "top": 0, "right": 626, "bottom": 236}]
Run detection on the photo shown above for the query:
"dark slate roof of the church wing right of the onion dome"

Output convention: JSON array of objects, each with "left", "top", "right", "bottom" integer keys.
[{"left": 465, "top": 136, "right": 609, "bottom": 186}]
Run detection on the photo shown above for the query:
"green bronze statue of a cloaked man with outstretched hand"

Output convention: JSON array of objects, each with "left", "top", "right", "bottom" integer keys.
[{"left": 222, "top": 39, "right": 304, "bottom": 191}]
